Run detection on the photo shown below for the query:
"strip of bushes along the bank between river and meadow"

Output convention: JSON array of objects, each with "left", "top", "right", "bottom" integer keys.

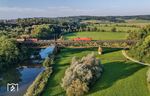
[{"left": 24, "top": 56, "right": 54, "bottom": 96}]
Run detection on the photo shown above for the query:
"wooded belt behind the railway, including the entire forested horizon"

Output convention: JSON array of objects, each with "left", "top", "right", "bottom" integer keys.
[{"left": 0, "top": 15, "right": 150, "bottom": 39}]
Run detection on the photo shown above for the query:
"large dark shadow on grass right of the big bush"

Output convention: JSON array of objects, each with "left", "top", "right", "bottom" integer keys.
[{"left": 89, "top": 62, "right": 144, "bottom": 94}]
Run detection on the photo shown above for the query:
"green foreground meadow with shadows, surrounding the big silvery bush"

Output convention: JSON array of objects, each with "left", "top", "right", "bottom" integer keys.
[{"left": 43, "top": 48, "right": 150, "bottom": 96}]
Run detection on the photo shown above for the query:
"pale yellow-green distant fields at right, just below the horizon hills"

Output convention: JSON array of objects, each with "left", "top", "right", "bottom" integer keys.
[{"left": 82, "top": 19, "right": 150, "bottom": 32}]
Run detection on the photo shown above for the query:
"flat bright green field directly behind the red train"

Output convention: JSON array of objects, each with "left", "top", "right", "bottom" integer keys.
[{"left": 64, "top": 32, "right": 128, "bottom": 40}]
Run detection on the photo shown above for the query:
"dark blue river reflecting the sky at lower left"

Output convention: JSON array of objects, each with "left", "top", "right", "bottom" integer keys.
[{"left": 0, "top": 46, "right": 54, "bottom": 96}]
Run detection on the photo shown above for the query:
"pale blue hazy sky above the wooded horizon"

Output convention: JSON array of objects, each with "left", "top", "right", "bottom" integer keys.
[{"left": 0, "top": 0, "right": 150, "bottom": 19}]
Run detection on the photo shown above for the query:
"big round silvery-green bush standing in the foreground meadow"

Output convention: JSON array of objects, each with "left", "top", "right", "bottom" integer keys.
[{"left": 61, "top": 53, "right": 103, "bottom": 96}]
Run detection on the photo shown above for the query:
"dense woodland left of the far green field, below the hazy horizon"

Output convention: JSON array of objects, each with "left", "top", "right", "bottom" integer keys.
[{"left": 0, "top": 19, "right": 86, "bottom": 39}]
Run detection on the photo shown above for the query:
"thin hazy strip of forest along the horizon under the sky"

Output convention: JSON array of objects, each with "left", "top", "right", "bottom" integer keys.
[{"left": 0, "top": 15, "right": 150, "bottom": 25}]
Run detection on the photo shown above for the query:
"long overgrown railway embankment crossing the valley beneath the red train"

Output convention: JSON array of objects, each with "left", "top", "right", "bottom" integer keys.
[{"left": 18, "top": 40, "right": 137, "bottom": 48}]
